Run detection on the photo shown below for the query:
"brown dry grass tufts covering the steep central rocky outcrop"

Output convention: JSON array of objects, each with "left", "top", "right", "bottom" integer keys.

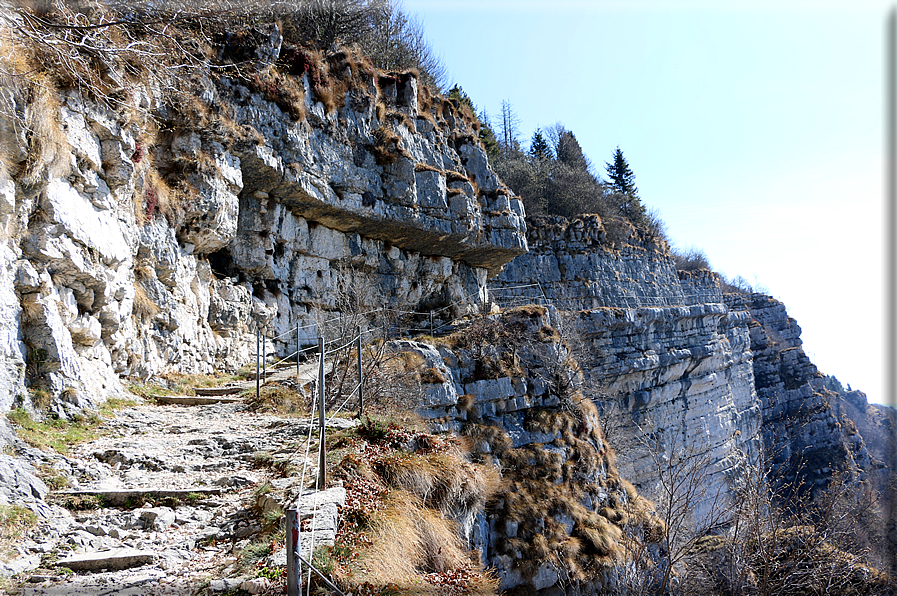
[{"left": 466, "top": 392, "right": 659, "bottom": 579}]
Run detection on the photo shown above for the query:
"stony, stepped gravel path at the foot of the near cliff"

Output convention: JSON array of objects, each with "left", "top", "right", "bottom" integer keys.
[{"left": 7, "top": 403, "right": 351, "bottom": 596}]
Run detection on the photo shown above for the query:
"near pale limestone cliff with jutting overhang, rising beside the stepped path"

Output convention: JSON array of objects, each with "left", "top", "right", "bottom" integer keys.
[{"left": 0, "top": 58, "right": 526, "bottom": 415}]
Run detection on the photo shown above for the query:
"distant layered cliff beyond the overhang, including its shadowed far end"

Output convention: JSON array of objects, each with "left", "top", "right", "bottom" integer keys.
[{"left": 490, "top": 216, "right": 876, "bottom": 516}]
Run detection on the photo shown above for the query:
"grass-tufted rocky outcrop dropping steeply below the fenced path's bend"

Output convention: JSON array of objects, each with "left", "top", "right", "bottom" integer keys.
[{"left": 393, "top": 306, "right": 659, "bottom": 595}]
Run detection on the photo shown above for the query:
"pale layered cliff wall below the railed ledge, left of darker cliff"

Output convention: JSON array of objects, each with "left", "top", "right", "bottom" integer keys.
[{"left": 579, "top": 304, "right": 761, "bottom": 517}]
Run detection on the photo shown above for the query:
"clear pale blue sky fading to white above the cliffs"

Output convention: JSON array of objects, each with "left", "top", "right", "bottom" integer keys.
[{"left": 404, "top": 0, "right": 894, "bottom": 402}]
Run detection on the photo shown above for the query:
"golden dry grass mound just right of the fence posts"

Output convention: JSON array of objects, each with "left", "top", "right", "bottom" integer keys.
[{"left": 331, "top": 423, "right": 499, "bottom": 594}]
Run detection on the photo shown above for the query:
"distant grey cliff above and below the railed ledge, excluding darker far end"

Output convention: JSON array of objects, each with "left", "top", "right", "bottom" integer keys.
[{"left": 490, "top": 216, "right": 762, "bottom": 516}]
